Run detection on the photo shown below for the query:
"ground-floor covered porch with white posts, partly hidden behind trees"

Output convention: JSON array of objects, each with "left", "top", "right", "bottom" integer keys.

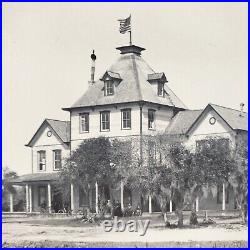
[{"left": 9, "top": 175, "right": 229, "bottom": 213}]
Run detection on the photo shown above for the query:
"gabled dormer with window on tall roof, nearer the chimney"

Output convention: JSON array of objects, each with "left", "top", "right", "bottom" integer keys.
[{"left": 100, "top": 71, "right": 122, "bottom": 96}]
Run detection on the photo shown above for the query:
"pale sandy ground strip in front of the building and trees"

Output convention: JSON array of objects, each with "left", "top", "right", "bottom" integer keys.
[{"left": 2, "top": 214, "right": 248, "bottom": 243}]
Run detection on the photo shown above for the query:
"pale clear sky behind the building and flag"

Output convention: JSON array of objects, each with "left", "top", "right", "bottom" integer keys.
[{"left": 2, "top": 3, "right": 248, "bottom": 174}]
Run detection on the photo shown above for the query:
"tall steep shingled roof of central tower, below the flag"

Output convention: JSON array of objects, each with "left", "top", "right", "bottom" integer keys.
[{"left": 64, "top": 46, "right": 186, "bottom": 110}]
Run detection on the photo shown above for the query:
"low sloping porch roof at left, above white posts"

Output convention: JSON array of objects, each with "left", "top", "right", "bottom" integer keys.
[{"left": 10, "top": 173, "right": 59, "bottom": 185}]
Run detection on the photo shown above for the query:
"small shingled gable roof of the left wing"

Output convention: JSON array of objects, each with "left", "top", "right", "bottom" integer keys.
[{"left": 25, "top": 119, "right": 70, "bottom": 147}]
